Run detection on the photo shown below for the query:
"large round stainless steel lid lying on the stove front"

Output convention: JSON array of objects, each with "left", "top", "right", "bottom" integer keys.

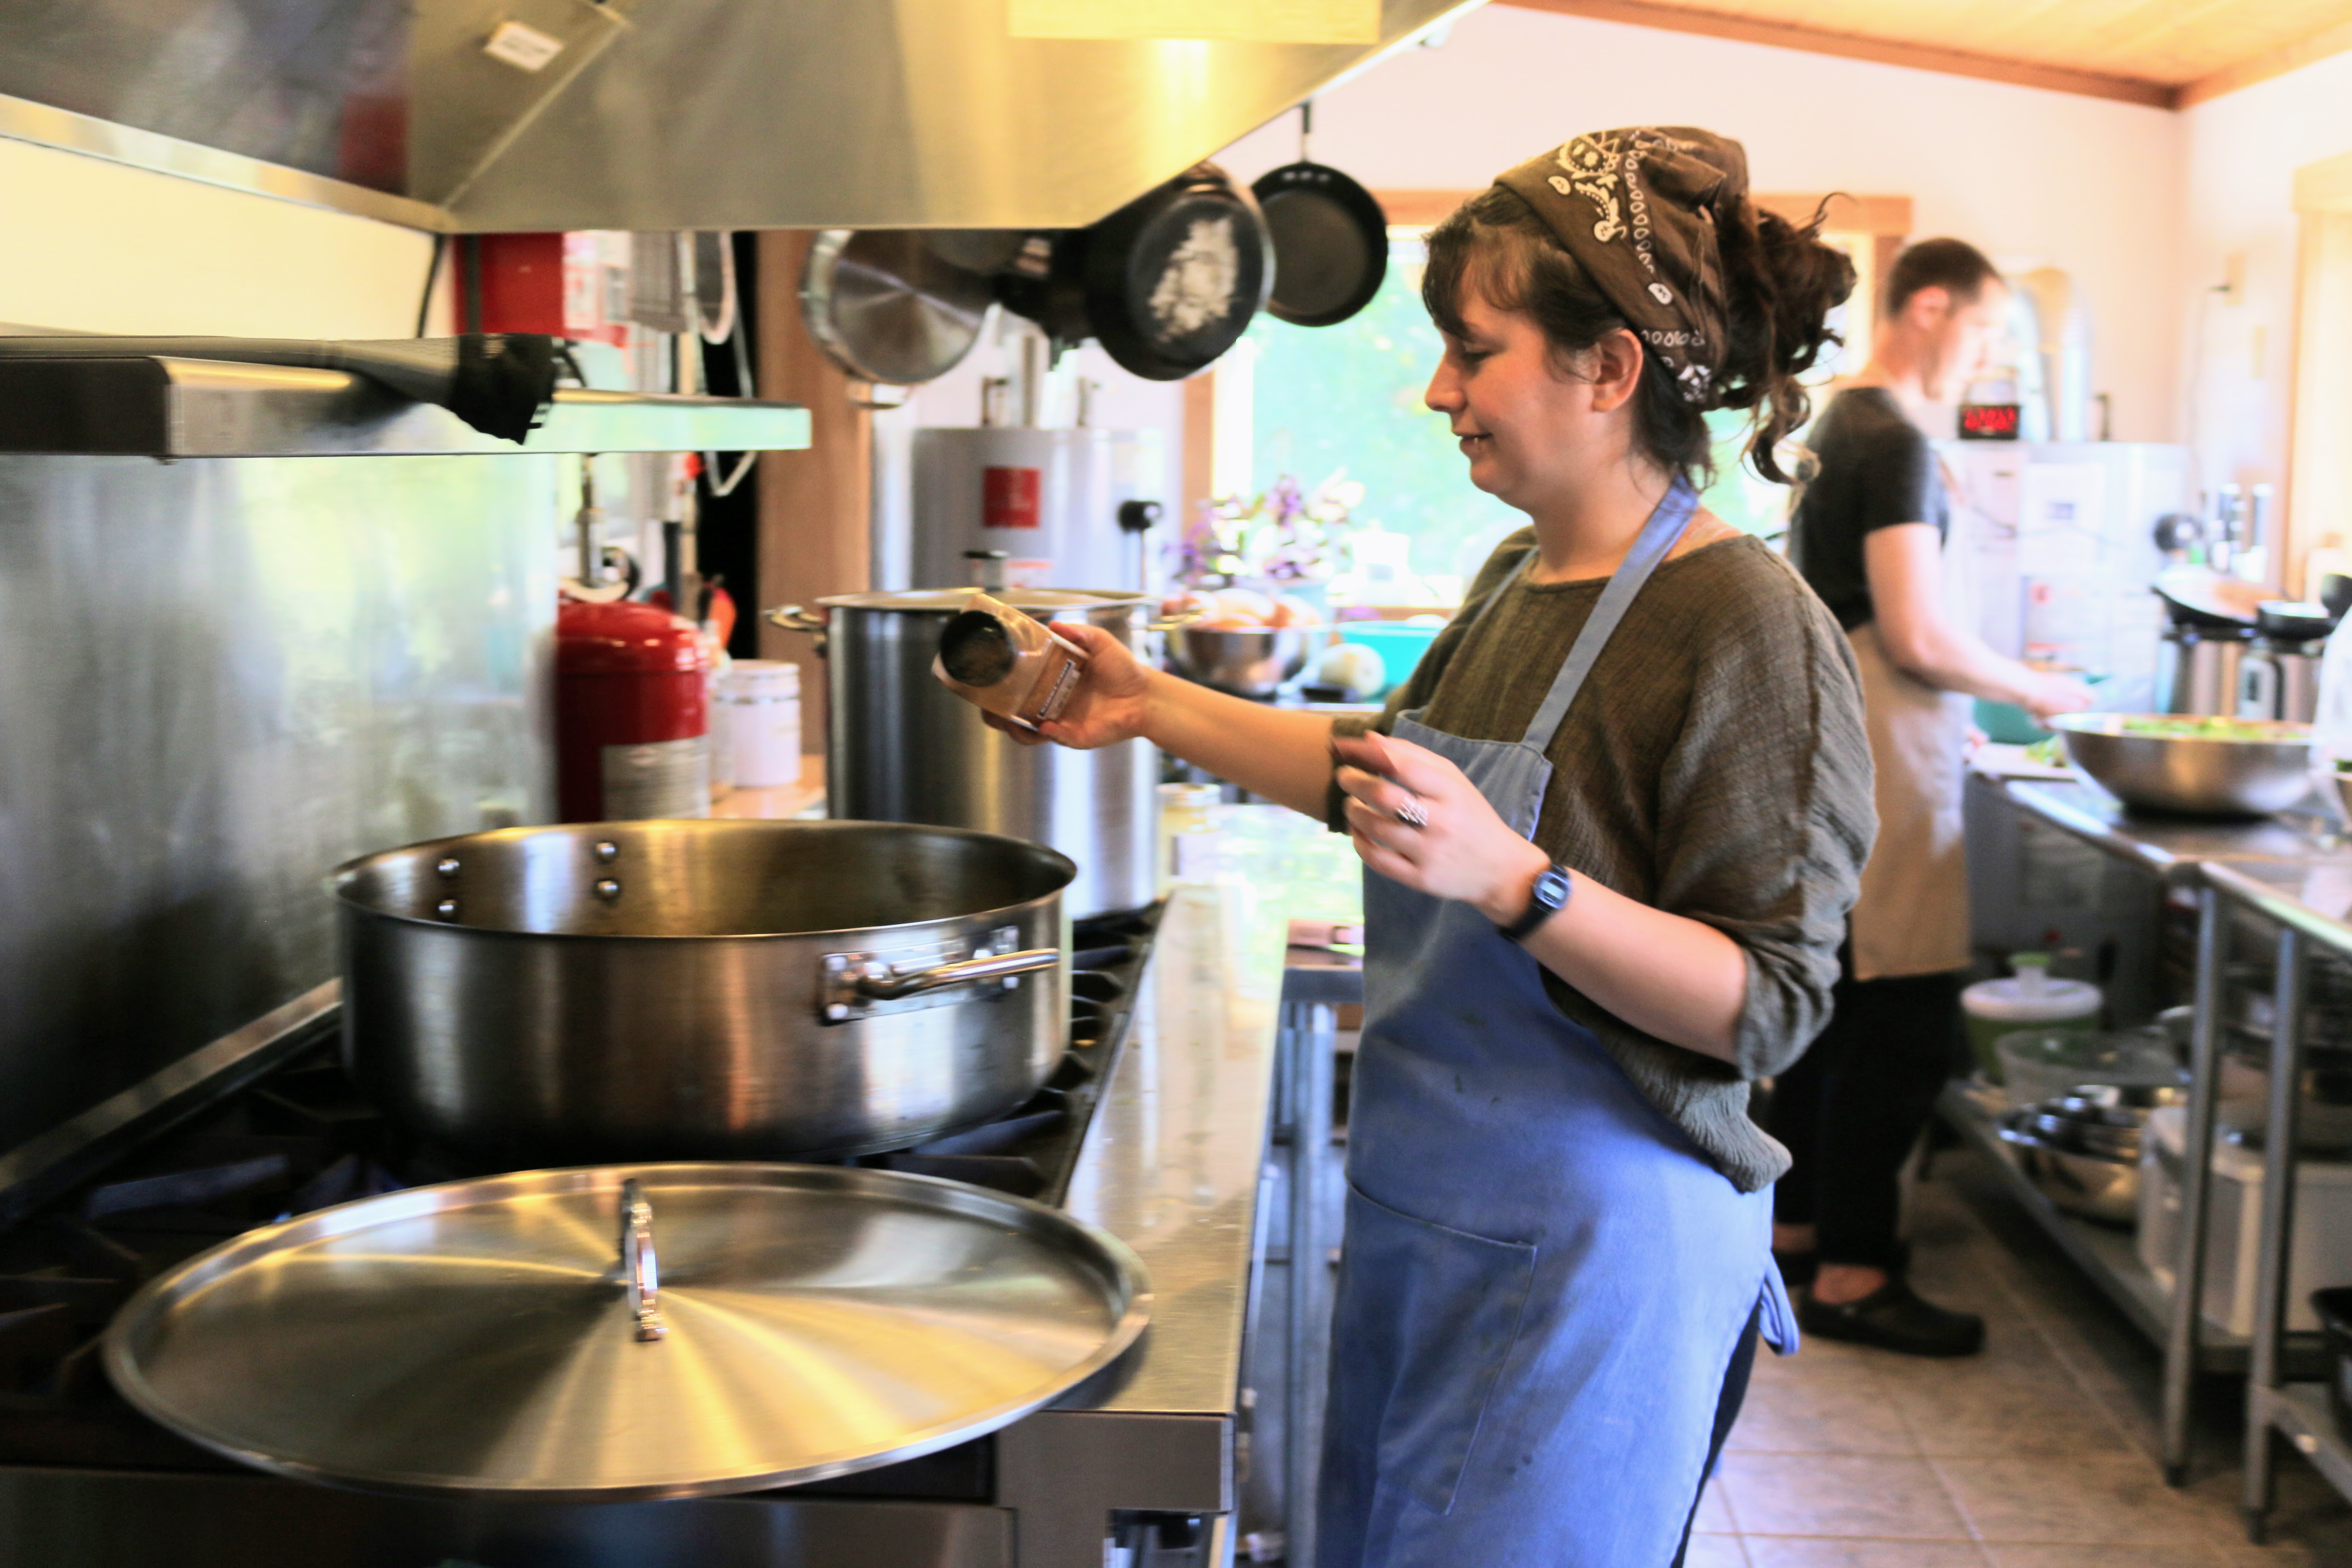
[{"left": 106, "top": 1164, "right": 1150, "bottom": 1502}]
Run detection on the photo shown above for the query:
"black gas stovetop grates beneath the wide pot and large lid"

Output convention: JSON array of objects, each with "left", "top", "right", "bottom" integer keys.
[{"left": 0, "top": 910, "right": 1157, "bottom": 1504}]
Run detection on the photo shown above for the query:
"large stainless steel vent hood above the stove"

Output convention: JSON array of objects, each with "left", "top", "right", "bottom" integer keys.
[{"left": 0, "top": 0, "right": 1477, "bottom": 233}]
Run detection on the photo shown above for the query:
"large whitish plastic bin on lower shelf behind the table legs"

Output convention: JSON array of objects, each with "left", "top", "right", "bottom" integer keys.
[{"left": 2138, "top": 1102, "right": 2352, "bottom": 1335}]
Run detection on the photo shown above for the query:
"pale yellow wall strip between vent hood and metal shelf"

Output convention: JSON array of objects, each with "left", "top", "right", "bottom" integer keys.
[{"left": 0, "top": 141, "right": 433, "bottom": 339}]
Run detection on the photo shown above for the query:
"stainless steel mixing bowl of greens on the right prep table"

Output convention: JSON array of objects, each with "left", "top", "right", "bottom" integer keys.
[{"left": 2049, "top": 712, "right": 2312, "bottom": 816}]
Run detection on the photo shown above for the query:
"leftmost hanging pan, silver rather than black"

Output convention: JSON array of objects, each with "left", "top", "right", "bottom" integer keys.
[{"left": 799, "top": 228, "right": 995, "bottom": 386}]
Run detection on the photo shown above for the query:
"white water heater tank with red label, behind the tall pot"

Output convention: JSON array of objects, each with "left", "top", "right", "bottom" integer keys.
[{"left": 910, "top": 426, "right": 1171, "bottom": 590}]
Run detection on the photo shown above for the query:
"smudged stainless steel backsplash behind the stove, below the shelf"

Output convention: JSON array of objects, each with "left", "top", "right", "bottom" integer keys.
[{"left": 0, "top": 456, "right": 560, "bottom": 1152}]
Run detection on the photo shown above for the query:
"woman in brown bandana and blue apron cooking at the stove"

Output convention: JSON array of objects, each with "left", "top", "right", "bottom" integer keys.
[{"left": 1011, "top": 127, "right": 1872, "bottom": 1568}]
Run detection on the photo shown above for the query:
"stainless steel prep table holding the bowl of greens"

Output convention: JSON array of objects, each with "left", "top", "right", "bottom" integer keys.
[{"left": 1943, "top": 781, "right": 2352, "bottom": 1486}]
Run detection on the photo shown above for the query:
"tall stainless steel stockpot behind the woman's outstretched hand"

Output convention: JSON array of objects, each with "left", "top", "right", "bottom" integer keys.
[{"left": 772, "top": 588, "right": 1160, "bottom": 919}]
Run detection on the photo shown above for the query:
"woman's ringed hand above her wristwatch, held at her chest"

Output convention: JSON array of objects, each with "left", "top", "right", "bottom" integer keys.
[{"left": 1331, "top": 736, "right": 1550, "bottom": 926}]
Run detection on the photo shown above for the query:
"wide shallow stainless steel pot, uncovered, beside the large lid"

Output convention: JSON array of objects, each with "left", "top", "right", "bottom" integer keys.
[{"left": 334, "top": 821, "right": 1072, "bottom": 1168}]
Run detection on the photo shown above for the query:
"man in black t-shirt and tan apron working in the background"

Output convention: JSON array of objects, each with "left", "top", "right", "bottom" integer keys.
[{"left": 1766, "top": 240, "right": 2091, "bottom": 1357}]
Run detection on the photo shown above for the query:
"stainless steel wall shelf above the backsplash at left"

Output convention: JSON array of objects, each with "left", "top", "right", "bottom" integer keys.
[{"left": 0, "top": 355, "right": 809, "bottom": 461}]
